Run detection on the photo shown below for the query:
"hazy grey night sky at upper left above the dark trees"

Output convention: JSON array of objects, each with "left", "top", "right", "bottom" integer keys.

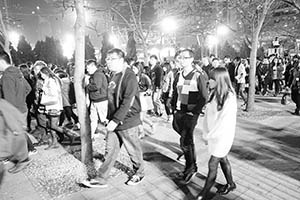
[{"left": 0, "top": 0, "right": 99, "bottom": 47}]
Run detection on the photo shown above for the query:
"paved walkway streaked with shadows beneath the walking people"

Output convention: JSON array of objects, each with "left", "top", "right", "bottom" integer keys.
[{"left": 0, "top": 97, "right": 300, "bottom": 200}]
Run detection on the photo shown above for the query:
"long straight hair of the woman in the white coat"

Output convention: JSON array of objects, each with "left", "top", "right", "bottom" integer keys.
[{"left": 208, "top": 67, "right": 235, "bottom": 111}]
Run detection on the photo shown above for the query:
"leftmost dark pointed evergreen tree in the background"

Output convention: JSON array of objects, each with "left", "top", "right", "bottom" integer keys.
[{"left": 17, "top": 35, "right": 34, "bottom": 63}]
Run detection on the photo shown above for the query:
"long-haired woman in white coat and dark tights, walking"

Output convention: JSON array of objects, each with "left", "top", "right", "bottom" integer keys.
[{"left": 198, "top": 67, "right": 237, "bottom": 199}]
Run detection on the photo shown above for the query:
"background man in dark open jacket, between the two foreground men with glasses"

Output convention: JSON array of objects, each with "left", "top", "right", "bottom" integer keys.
[{"left": 150, "top": 55, "right": 164, "bottom": 117}]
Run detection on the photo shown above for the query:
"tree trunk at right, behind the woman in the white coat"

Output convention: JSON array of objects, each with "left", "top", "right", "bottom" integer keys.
[{"left": 246, "top": 29, "right": 260, "bottom": 111}]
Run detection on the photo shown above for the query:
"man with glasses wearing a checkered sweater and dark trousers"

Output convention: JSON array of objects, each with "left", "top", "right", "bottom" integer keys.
[{"left": 172, "top": 49, "right": 208, "bottom": 184}]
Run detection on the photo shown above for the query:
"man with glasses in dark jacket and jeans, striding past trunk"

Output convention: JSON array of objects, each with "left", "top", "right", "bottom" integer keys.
[{"left": 82, "top": 49, "right": 144, "bottom": 188}]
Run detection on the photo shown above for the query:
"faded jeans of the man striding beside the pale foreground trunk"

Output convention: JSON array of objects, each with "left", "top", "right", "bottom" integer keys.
[{"left": 98, "top": 126, "right": 144, "bottom": 180}]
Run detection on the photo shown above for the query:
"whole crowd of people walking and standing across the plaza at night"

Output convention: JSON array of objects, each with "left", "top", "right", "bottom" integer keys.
[{"left": 0, "top": 46, "right": 300, "bottom": 199}]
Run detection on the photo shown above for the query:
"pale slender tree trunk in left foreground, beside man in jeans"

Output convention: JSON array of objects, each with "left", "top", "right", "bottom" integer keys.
[{"left": 74, "top": 0, "right": 93, "bottom": 166}]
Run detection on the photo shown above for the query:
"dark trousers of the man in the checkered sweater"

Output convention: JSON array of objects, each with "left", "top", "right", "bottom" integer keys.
[{"left": 172, "top": 111, "right": 199, "bottom": 174}]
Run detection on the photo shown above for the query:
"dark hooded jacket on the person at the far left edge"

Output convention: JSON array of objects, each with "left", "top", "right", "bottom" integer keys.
[{"left": 0, "top": 66, "right": 32, "bottom": 113}]
